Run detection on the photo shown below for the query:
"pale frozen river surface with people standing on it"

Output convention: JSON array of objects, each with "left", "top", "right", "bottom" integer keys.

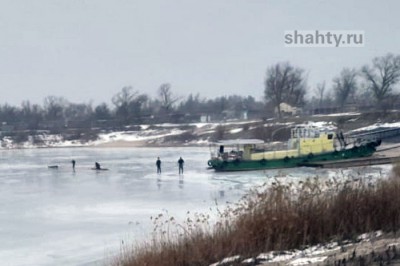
[{"left": 0, "top": 148, "right": 390, "bottom": 266}]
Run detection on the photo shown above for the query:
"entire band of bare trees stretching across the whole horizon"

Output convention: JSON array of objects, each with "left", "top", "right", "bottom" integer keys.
[{"left": 0, "top": 54, "right": 400, "bottom": 130}]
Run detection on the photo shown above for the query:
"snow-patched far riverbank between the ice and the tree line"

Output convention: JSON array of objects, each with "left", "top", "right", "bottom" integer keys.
[{"left": 0, "top": 120, "right": 400, "bottom": 149}]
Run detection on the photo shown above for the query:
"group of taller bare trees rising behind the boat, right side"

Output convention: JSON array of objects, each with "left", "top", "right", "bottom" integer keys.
[{"left": 264, "top": 53, "right": 400, "bottom": 117}]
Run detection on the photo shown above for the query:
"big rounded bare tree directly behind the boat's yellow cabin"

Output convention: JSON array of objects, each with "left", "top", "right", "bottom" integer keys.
[{"left": 264, "top": 63, "right": 305, "bottom": 117}]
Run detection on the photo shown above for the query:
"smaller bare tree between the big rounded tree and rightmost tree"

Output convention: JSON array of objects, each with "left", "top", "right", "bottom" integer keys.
[{"left": 333, "top": 68, "right": 357, "bottom": 109}]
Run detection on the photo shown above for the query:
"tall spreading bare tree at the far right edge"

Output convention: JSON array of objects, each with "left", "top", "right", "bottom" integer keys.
[{"left": 361, "top": 53, "right": 400, "bottom": 109}]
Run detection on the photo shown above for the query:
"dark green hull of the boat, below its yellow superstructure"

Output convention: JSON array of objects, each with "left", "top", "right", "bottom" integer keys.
[{"left": 208, "top": 142, "right": 380, "bottom": 172}]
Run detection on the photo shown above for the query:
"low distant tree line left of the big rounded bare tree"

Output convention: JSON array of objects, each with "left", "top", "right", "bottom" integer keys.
[{"left": 0, "top": 83, "right": 264, "bottom": 130}]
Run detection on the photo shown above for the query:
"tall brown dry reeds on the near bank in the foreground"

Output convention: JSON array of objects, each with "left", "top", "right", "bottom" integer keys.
[{"left": 113, "top": 166, "right": 400, "bottom": 266}]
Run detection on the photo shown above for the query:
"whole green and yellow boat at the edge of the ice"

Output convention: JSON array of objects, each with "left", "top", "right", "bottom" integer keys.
[{"left": 208, "top": 125, "right": 381, "bottom": 171}]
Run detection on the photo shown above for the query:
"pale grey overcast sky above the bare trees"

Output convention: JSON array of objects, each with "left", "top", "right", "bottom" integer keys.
[{"left": 0, "top": 0, "right": 400, "bottom": 105}]
